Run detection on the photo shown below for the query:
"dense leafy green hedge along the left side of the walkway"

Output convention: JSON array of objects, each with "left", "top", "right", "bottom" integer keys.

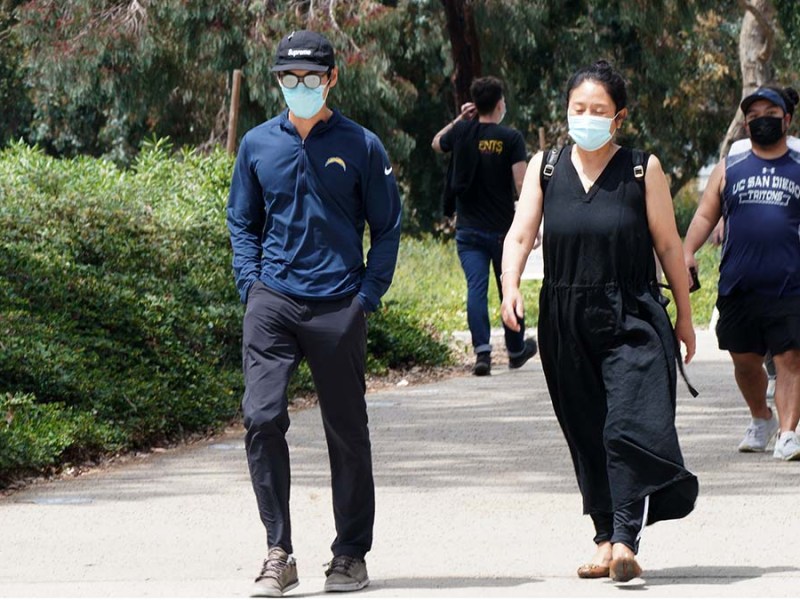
[{"left": 0, "top": 141, "right": 449, "bottom": 480}]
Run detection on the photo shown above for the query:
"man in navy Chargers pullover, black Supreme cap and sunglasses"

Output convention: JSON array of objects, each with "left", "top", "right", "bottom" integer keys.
[{"left": 227, "top": 31, "right": 401, "bottom": 596}]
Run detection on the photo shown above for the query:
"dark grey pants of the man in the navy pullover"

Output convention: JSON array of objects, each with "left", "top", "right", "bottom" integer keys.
[{"left": 242, "top": 282, "right": 375, "bottom": 558}]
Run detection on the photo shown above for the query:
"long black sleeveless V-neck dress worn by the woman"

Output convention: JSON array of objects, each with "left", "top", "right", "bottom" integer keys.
[{"left": 539, "top": 146, "right": 698, "bottom": 524}]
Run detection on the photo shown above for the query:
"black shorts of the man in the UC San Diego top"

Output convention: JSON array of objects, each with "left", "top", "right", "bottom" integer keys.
[{"left": 717, "top": 293, "right": 800, "bottom": 356}]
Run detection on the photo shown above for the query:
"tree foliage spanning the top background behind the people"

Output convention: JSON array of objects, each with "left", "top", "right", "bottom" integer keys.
[{"left": 0, "top": 0, "right": 800, "bottom": 225}]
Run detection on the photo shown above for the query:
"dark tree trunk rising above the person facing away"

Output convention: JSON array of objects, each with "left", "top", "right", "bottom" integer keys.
[{"left": 442, "top": 0, "right": 481, "bottom": 114}]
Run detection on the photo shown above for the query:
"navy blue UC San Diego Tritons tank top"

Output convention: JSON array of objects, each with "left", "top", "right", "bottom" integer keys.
[{"left": 719, "top": 150, "right": 800, "bottom": 297}]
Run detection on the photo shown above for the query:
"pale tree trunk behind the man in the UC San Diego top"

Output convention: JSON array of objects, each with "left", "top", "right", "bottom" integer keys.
[{"left": 719, "top": 0, "right": 775, "bottom": 158}]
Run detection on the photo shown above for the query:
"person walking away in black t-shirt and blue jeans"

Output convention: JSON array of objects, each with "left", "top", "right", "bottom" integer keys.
[{"left": 431, "top": 77, "right": 537, "bottom": 375}]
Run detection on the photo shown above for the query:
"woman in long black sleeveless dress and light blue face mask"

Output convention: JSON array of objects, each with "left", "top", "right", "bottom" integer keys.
[{"left": 502, "top": 61, "right": 698, "bottom": 581}]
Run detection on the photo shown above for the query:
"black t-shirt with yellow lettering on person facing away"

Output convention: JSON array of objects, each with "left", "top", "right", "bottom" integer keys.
[{"left": 439, "top": 121, "right": 527, "bottom": 233}]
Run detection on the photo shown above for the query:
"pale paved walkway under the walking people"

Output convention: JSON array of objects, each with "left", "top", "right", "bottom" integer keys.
[{"left": 0, "top": 333, "right": 800, "bottom": 598}]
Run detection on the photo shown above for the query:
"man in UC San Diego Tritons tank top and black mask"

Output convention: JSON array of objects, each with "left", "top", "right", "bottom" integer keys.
[{"left": 684, "top": 86, "right": 800, "bottom": 460}]
